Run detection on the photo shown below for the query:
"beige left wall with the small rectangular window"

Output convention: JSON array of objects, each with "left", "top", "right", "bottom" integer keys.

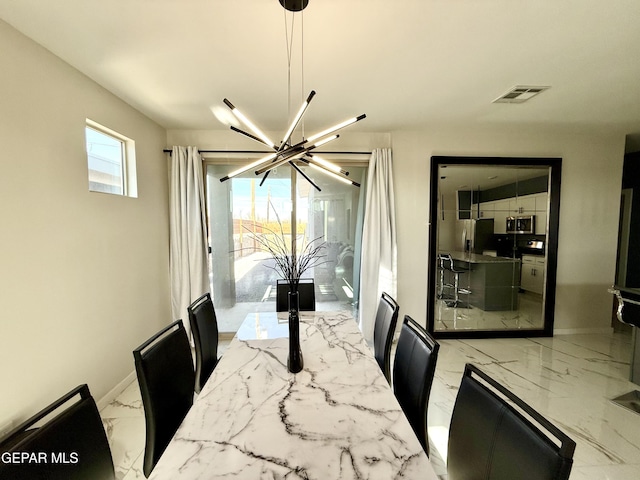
[{"left": 0, "top": 22, "right": 171, "bottom": 425}]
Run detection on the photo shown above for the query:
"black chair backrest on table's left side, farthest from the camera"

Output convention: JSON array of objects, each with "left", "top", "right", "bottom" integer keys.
[{"left": 187, "top": 293, "right": 218, "bottom": 393}]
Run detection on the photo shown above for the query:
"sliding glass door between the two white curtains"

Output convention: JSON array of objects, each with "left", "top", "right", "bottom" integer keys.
[{"left": 205, "top": 161, "right": 366, "bottom": 332}]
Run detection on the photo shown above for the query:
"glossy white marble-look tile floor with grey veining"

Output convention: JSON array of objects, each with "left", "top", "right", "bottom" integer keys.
[{"left": 101, "top": 333, "right": 640, "bottom": 480}]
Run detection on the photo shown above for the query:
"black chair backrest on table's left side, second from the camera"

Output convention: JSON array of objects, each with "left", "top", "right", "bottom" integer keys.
[{"left": 133, "top": 320, "right": 195, "bottom": 477}]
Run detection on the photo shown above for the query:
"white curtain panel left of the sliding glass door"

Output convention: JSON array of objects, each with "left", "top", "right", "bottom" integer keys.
[{"left": 169, "top": 147, "right": 210, "bottom": 336}]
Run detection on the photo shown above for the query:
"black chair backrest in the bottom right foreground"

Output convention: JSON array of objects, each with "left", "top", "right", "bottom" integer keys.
[{"left": 447, "top": 364, "right": 576, "bottom": 480}]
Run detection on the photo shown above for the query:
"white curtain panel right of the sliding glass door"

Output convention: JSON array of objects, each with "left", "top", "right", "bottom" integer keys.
[{"left": 359, "top": 148, "right": 397, "bottom": 342}]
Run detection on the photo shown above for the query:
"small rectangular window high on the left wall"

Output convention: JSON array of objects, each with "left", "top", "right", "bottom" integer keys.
[{"left": 85, "top": 119, "right": 136, "bottom": 197}]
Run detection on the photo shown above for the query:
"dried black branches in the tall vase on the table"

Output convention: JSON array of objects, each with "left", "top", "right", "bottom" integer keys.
[{"left": 245, "top": 205, "right": 327, "bottom": 292}]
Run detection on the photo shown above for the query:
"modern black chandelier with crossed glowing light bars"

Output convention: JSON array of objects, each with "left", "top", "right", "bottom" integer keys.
[{"left": 220, "top": 0, "right": 366, "bottom": 190}]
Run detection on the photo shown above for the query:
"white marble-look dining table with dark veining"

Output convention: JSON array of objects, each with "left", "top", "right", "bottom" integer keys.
[{"left": 149, "top": 312, "right": 438, "bottom": 480}]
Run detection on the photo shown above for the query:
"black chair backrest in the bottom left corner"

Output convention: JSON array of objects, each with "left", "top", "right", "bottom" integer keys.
[{"left": 0, "top": 385, "right": 115, "bottom": 480}]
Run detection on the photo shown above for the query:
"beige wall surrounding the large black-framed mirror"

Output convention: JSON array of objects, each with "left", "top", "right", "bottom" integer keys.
[{"left": 392, "top": 128, "right": 625, "bottom": 333}]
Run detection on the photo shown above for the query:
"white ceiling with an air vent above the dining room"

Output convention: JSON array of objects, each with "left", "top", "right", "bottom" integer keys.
[{"left": 0, "top": 0, "right": 640, "bottom": 138}]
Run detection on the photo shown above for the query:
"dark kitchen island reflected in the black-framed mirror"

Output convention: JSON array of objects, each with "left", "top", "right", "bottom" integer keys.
[{"left": 445, "top": 251, "right": 520, "bottom": 311}]
